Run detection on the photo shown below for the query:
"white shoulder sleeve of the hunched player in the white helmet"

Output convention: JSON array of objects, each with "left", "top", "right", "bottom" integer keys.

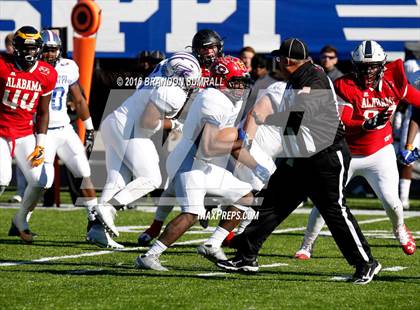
[{"left": 150, "top": 86, "right": 187, "bottom": 118}]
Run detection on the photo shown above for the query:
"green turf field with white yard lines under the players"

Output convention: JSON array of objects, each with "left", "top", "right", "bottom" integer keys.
[{"left": 0, "top": 197, "right": 420, "bottom": 309}]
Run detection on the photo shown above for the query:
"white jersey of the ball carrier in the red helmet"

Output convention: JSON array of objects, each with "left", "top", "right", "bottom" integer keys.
[{"left": 167, "top": 88, "right": 243, "bottom": 177}]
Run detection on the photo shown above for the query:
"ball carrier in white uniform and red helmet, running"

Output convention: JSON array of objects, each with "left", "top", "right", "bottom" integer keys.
[{"left": 136, "top": 56, "right": 269, "bottom": 271}]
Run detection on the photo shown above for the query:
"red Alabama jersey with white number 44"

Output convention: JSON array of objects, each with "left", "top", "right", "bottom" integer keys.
[{"left": 0, "top": 55, "right": 57, "bottom": 139}]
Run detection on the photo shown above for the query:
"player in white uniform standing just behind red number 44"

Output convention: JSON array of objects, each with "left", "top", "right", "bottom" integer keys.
[{"left": 37, "top": 30, "right": 97, "bottom": 232}]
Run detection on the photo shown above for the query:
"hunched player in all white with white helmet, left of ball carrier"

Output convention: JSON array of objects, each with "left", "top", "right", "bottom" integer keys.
[{"left": 88, "top": 52, "right": 201, "bottom": 247}]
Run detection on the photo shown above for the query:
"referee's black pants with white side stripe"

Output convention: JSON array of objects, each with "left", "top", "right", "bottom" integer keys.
[{"left": 232, "top": 141, "right": 373, "bottom": 265}]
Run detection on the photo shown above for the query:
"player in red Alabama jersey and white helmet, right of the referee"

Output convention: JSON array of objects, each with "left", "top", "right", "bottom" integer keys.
[{"left": 295, "top": 41, "right": 420, "bottom": 259}]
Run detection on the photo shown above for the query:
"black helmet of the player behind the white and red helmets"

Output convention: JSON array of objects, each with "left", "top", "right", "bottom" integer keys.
[{"left": 192, "top": 29, "right": 224, "bottom": 67}]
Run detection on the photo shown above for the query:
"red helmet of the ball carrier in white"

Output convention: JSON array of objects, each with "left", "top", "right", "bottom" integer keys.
[{"left": 210, "top": 56, "right": 251, "bottom": 101}]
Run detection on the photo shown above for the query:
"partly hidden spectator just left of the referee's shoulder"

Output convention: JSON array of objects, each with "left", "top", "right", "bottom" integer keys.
[{"left": 244, "top": 54, "right": 277, "bottom": 115}]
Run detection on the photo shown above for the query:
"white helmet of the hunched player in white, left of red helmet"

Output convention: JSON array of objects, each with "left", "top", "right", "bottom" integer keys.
[{"left": 164, "top": 52, "right": 201, "bottom": 89}]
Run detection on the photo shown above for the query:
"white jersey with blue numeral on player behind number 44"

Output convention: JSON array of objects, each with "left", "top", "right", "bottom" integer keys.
[{"left": 48, "top": 58, "right": 79, "bottom": 128}]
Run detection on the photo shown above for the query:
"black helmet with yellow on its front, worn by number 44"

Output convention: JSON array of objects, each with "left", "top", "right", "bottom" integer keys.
[{"left": 13, "top": 26, "right": 42, "bottom": 70}]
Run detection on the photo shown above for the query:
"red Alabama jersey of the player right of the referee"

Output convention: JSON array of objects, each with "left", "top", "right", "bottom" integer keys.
[{"left": 334, "top": 59, "right": 408, "bottom": 156}]
